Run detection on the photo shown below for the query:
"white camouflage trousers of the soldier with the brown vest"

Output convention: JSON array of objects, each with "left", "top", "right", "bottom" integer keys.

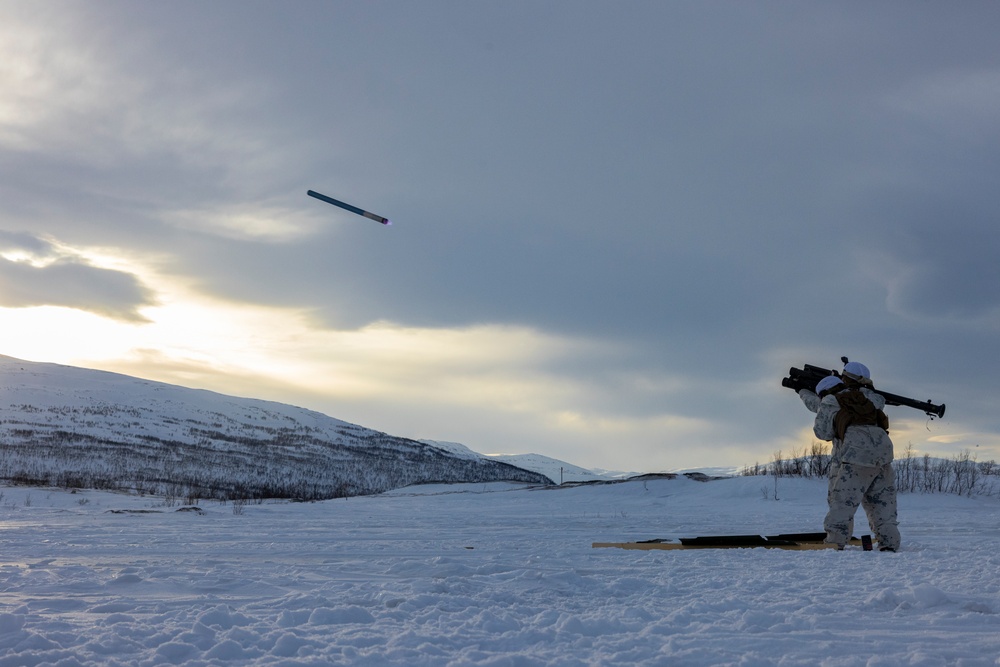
[{"left": 823, "top": 462, "right": 900, "bottom": 550}]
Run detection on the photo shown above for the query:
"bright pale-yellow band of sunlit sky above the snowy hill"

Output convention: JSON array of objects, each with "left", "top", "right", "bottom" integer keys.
[{"left": 0, "top": 243, "right": 732, "bottom": 467}]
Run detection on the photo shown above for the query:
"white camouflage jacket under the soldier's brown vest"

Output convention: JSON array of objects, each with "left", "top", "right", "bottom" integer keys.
[{"left": 799, "top": 387, "right": 893, "bottom": 468}]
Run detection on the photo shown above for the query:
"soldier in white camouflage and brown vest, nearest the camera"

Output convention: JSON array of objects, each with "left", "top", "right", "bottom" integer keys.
[{"left": 799, "top": 361, "right": 900, "bottom": 551}]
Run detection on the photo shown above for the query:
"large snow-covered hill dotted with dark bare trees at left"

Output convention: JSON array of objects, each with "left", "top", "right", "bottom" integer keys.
[{"left": 0, "top": 355, "right": 552, "bottom": 500}]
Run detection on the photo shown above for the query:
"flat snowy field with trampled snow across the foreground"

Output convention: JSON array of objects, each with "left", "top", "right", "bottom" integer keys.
[{"left": 0, "top": 478, "right": 1000, "bottom": 667}]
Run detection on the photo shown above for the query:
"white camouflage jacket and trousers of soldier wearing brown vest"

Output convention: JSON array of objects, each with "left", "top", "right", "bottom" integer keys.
[{"left": 799, "top": 387, "right": 900, "bottom": 550}]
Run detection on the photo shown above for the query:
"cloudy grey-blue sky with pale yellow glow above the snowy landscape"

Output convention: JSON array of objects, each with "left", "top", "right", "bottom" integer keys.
[{"left": 0, "top": 0, "right": 1000, "bottom": 472}]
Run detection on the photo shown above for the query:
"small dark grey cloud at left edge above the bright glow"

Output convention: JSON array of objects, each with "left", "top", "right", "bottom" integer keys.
[{"left": 0, "top": 231, "right": 155, "bottom": 322}]
